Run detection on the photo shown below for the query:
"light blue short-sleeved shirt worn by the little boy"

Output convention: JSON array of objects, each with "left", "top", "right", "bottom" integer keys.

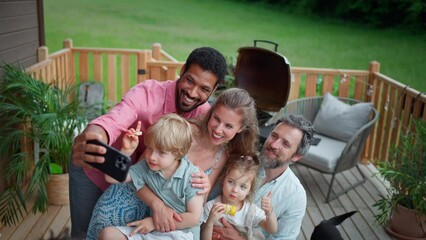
[{"left": 129, "top": 157, "right": 200, "bottom": 239}]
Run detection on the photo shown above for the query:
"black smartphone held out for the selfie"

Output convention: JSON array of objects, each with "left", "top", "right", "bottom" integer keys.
[{"left": 87, "top": 140, "right": 131, "bottom": 182}]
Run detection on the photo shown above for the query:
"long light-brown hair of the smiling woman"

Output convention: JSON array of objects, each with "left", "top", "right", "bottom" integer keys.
[{"left": 194, "top": 88, "right": 259, "bottom": 155}]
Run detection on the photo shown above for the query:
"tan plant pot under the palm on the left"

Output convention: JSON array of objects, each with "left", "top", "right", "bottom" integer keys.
[{"left": 46, "top": 173, "right": 69, "bottom": 205}]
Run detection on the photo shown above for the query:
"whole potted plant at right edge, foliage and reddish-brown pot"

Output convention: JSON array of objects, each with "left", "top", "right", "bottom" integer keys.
[{"left": 374, "top": 120, "right": 426, "bottom": 239}]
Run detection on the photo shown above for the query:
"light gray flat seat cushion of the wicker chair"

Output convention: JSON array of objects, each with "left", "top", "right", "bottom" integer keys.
[{"left": 298, "top": 134, "right": 346, "bottom": 173}]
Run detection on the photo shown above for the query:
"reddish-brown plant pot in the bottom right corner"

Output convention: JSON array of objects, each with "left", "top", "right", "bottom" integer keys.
[{"left": 386, "top": 205, "right": 426, "bottom": 240}]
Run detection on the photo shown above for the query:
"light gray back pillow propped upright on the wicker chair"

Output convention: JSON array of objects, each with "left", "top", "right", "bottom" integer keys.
[{"left": 314, "top": 93, "right": 373, "bottom": 142}]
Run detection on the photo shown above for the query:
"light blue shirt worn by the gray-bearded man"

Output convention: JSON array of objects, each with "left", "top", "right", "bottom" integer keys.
[{"left": 254, "top": 168, "right": 306, "bottom": 239}]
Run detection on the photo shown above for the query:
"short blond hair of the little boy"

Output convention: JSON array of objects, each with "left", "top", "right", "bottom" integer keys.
[{"left": 144, "top": 113, "right": 193, "bottom": 159}]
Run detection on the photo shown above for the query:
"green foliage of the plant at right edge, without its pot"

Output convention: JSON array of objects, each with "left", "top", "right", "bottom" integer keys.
[{"left": 373, "top": 120, "right": 426, "bottom": 225}]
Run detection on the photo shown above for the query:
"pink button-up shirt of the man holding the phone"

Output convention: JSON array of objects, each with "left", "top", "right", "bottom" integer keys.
[{"left": 84, "top": 80, "right": 210, "bottom": 190}]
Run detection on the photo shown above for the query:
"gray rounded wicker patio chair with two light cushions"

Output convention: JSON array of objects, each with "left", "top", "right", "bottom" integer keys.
[{"left": 260, "top": 94, "right": 378, "bottom": 203}]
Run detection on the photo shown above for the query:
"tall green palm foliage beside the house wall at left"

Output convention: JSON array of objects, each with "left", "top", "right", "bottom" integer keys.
[{"left": 0, "top": 65, "right": 87, "bottom": 225}]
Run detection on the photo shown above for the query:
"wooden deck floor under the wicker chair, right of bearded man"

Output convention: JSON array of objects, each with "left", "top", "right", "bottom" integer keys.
[{"left": 291, "top": 164, "right": 391, "bottom": 240}]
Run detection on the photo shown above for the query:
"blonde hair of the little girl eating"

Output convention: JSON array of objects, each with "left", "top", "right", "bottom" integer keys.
[{"left": 221, "top": 155, "right": 260, "bottom": 201}]
